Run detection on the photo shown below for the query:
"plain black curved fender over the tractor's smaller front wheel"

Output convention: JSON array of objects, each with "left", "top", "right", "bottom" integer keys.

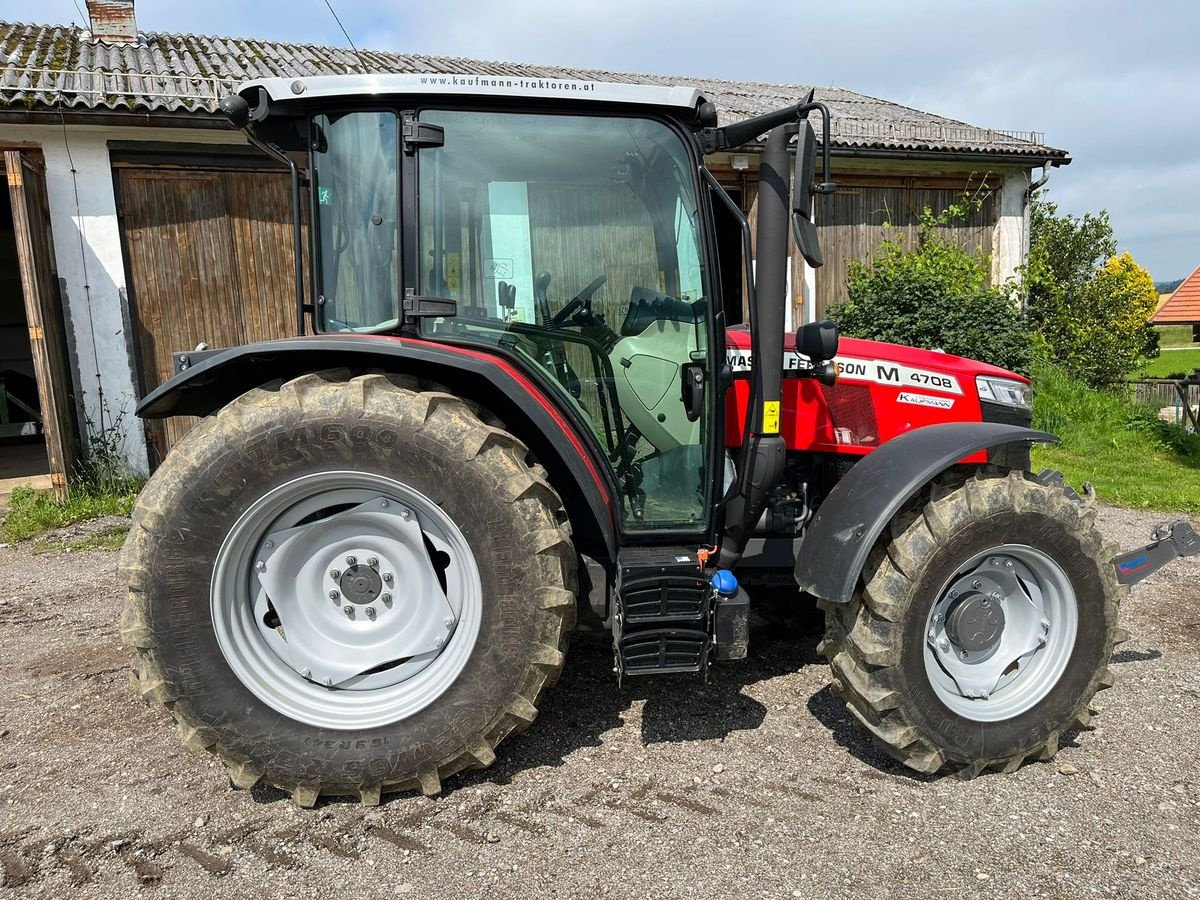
[{"left": 796, "top": 422, "right": 1058, "bottom": 604}]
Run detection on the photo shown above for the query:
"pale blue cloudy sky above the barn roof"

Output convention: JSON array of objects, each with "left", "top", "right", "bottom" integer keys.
[{"left": 16, "top": 0, "right": 1200, "bottom": 281}]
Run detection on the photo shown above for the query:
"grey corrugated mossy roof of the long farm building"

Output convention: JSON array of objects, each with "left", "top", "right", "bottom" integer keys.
[{"left": 0, "top": 22, "right": 1067, "bottom": 160}]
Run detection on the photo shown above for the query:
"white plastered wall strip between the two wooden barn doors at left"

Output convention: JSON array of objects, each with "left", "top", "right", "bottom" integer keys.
[{"left": 0, "top": 125, "right": 242, "bottom": 474}]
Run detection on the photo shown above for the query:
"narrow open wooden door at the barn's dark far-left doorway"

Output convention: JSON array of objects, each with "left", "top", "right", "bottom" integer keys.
[{"left": 4, "top": 150, "right": 79, "bottom": 499}]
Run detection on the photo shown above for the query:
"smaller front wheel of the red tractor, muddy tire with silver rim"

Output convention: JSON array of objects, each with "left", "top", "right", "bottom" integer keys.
[{"left": 818, "top": 468, "right": 1128, "bottom": 778}]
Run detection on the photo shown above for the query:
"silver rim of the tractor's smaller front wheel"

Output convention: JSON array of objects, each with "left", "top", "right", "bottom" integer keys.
[{"left": 924, "top": 544, "right": 1079, "bottom": 722}]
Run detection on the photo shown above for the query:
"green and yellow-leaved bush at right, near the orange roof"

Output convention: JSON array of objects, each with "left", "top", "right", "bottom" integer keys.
[{"left": 1022, "top": 200, "right": 1158, "bottom": 388}]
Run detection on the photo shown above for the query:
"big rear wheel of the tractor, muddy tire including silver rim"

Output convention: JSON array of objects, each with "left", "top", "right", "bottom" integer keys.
[{"left": 120, "top": 371, "right": 576, "bottom": 806}]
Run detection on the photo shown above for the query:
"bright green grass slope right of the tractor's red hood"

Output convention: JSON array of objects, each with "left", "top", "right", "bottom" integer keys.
[{"left": 1033, "top": 362, "right": 1200, "bottom": 514}]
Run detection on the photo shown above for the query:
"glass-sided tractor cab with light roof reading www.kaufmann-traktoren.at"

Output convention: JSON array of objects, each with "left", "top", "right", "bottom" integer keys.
[{"left": 223, "top": 76, "right": 835, "bottom": 544}]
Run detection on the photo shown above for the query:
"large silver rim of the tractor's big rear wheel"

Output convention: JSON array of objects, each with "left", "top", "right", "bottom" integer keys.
[{"left": 210, "top": 472, "right": 482, "bottom": 730}]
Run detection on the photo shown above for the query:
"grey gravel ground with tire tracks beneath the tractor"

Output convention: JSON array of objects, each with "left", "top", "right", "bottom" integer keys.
[{"left": 0, "top": 509, "right": 1200, "bottom": 898}]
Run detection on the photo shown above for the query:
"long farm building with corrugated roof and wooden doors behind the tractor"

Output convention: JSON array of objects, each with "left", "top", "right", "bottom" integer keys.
[{"left": 0, "top": 0, "right": 1069, "bottom": 481}]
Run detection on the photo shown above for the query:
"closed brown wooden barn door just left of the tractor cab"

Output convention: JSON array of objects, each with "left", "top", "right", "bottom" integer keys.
[{"left": 116, "top": 166, "right": 295, "bottom": 458}]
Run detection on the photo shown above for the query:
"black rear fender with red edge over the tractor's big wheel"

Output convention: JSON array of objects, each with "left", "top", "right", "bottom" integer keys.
[{"left": 137, "top": 335, "right": 617, "bottom": 560}]
